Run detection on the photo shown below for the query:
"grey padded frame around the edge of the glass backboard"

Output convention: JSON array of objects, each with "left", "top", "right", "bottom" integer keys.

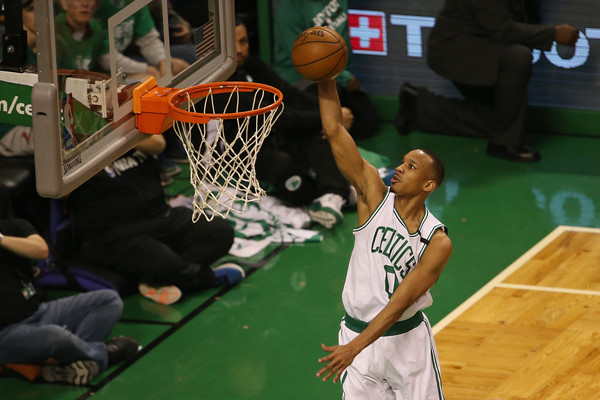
[{"left": 32, "top": 0, "right": 236, "bottom": 198}]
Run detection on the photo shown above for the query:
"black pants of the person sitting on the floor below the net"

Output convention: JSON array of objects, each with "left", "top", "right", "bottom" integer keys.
[{"left": 81, "top": 207, "right": 233, "bottom": 289}]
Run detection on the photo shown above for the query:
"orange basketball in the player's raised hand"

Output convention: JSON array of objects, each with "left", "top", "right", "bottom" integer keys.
[{"left": 292, "top": 26, "right": 348, "bottom": 82}]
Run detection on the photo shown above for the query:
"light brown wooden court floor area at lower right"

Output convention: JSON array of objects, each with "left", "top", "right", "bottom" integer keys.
[{"left": 433, "top": 226, "right": 600, "bottom": 400}]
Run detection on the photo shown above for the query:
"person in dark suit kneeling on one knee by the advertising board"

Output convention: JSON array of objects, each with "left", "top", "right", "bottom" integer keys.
[{"left": 395, "top": 0, "right": 579, "bottom": 162}]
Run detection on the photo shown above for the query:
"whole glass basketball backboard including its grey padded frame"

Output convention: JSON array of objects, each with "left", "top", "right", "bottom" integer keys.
[{"left": 31, "top": 0, "right": 236, "bottom": 198}]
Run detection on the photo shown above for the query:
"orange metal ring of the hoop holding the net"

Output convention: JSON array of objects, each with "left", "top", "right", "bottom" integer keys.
[{"left": 166, "top": 81, "right": 283, "bottom": 124}]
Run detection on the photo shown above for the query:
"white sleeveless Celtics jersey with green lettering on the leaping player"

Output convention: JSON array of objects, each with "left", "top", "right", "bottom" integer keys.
[{"left": 342, "top": 188, "right": 446, "bottom": 322}]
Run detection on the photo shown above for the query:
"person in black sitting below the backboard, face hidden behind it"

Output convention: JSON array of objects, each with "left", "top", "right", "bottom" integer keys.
[{"left": 69, "top": 135, "right": 245, "bottom": 304}]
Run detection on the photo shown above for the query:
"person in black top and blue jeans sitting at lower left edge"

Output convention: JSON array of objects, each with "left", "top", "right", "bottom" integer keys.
[{"left": 0, "top": 218, "right": 138, "bottom": 385}]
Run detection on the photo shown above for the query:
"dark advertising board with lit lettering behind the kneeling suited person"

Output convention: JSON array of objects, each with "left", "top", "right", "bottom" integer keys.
[{"left": 348, "top": 0, "right": 600, "bottom": 110}]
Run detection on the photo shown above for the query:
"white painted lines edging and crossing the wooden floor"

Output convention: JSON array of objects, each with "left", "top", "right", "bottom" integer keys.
[{"left": 432, "top": 225, "right": 600, "bottom": 335}]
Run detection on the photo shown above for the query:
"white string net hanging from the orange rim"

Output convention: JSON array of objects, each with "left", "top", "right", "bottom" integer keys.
[{"left": 173, "top": 87, "right": 283, "bottom": 222}]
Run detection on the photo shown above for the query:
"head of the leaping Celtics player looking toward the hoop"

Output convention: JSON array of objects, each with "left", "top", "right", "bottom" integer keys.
[{"left": 392, "top": 149, "right": 445, "bottom": 196}]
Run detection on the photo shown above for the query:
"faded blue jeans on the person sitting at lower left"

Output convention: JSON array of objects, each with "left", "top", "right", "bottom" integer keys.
[{"left": 0, "top": 289, "right": 123, "bottom": 370}]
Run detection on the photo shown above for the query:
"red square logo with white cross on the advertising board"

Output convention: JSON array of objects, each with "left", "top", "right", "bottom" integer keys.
[{"left": 348, "top": 10, "right": 387, "bottom": 56}]
